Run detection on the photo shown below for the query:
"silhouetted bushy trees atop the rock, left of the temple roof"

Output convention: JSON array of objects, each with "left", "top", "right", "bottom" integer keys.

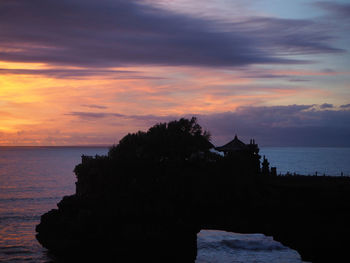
[{"left": 108, "top": 117, "right": 213, "bottom": 162}]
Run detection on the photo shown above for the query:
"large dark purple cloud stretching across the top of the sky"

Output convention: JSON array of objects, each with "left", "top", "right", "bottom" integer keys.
[{"left": 0, "top": 0, "right": 342, "bottom": 68}]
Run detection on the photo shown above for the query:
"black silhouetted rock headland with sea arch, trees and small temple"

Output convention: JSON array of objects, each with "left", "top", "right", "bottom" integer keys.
[{"left": 36, "top": 118, "right": 350, "bottom": 262}]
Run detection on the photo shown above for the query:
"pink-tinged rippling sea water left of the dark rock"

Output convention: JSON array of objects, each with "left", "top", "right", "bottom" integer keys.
[{"left": 0, "top": 147, "right": 107, "bottom": 263}]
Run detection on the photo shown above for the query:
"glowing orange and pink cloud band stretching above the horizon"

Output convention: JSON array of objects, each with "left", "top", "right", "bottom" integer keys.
[{"left": 0, "top": 62, "right": 348, "bottom": 145}]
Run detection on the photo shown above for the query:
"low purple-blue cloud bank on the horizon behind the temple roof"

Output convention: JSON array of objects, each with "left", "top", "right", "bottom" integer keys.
[{"left": 200, "top": 105, "right": 350, "bottom": 147}]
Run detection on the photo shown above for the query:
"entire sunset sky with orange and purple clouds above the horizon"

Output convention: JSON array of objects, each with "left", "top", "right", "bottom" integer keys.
[{"left": 0, "top": 0, "right": 350, "bottom": 147}]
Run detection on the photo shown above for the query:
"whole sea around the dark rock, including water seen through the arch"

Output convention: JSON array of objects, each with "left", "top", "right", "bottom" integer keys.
[{"left": 0, "top": 147, "right": 350, "bottom": 263}]
